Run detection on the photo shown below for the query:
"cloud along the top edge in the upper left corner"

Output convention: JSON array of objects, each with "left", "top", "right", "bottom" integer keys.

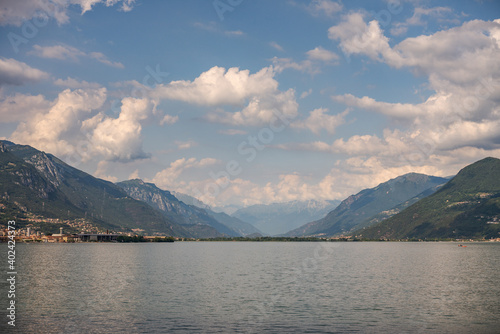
[{"left": 0, "top": 0, "right": 135, "bottom": 26}]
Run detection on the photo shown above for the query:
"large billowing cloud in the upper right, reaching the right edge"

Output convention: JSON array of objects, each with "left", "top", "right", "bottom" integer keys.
[{"left": 329, "top": 13, "right": 500, "bottom": 91}]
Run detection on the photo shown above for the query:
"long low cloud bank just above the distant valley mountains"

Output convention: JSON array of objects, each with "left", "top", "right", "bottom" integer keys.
[{"left": 168, "top": 157, "right": 446, "bottom": 206}]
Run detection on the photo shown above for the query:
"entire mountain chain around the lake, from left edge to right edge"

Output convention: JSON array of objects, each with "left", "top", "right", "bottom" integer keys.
[{"left": 0, "top": 141, "right": 500, "bottom": 239}]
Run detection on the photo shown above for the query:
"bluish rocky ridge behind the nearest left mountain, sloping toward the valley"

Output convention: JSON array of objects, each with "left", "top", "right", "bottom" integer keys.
[{"left": 117, "top": 183, "right": 259, "bottom": 237}]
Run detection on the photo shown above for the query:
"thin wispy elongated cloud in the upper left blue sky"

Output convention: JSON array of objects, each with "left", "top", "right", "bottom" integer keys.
[{"left": 29, "top": 45, "right": 124, "bottom": 68}]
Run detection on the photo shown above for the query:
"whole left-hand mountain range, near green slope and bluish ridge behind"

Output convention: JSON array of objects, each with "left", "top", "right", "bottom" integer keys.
[{"left": 0, "top": 141, "right": 261, "bottom": 238}]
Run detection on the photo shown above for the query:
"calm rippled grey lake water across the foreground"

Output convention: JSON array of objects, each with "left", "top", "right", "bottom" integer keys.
[{"left": 0, "top": 242, "right": 500, "bottom": 333}]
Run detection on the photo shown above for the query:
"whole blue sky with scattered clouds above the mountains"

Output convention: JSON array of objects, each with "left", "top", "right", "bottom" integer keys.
[{"left": 0, "top": 0, "right": 500, "bottom": 206}]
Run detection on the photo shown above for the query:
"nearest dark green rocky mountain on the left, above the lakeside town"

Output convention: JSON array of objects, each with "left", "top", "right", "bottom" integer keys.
[{"left": 0, "top": 141, "right": 191, "bottom": 236}]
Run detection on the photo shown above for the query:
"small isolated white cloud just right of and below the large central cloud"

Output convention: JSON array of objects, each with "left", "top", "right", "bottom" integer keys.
[{"left": 291, "top": 108, "right": 348, "bottom": 134}]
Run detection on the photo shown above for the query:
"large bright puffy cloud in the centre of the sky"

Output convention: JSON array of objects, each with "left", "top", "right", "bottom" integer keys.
[{"left": 150, "top": 66, "right": 298, "bottom": 126}]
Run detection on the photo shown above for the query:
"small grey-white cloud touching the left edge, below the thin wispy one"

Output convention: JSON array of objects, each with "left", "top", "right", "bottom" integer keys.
[{"left": 0, "top": 58, "right": 49, "bottom": 86}]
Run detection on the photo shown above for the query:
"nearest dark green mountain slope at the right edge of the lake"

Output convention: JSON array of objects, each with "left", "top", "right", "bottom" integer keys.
[{"left": 356, "top": 158, "right": 500, "bottom": 239}]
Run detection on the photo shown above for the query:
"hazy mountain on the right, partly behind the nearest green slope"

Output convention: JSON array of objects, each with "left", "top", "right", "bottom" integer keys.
[{"left": 286, "top": 173, "right": 448, "bottom": 236}]
